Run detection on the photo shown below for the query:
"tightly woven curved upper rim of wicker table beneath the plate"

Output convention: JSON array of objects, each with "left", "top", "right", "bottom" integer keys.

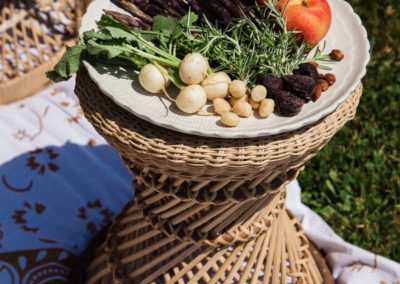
[{"left": 75, "top": 71, "right": 362, "bottom": 204}]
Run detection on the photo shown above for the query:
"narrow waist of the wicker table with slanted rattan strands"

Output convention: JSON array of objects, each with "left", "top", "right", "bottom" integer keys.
[{"left": 136, "top": 181, "right": 285, "bottom": 246}]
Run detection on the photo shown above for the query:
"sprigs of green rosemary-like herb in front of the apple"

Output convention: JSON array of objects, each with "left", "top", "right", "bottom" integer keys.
[{"left": 178, "top": 1, "right": 329, "bottom": 86}]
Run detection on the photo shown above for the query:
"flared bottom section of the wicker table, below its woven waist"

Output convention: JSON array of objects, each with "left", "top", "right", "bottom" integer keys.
[{"left": 85, "top": 201, "right": 333, "bottom": 284}]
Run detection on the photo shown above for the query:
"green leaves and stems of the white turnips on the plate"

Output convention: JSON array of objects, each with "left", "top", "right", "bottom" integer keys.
[{"left": 47, "top": 14, "right": 198, "bottom": 87}]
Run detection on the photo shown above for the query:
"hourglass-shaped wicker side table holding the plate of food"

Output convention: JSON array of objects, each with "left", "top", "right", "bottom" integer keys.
[{"left": 76, "top": 71, "right": 362, "bottom": 283}]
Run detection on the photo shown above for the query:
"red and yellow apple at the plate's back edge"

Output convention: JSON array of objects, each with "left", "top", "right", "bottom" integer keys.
[{"left": 257, "top": 0, "right": 332, "bottom": 46}]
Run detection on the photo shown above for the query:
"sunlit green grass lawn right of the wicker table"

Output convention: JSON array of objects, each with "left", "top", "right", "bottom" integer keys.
[{"left": 300, "top": 0, "right": 400, "bottom": 261}]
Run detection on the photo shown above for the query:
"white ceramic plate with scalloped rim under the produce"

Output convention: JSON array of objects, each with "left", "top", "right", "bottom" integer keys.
[{"left": 81, "top": 0, "right": 370, "bottom": 138}]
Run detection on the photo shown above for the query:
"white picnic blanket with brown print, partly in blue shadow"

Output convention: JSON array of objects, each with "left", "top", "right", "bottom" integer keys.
[{"left": 0, "top": 80, "right": 400, "bottom": 284}]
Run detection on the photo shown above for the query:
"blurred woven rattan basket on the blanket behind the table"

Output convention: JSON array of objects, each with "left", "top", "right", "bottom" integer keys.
[{"left": 0, "top": 0, "right": 87, "bottom": 104}]
